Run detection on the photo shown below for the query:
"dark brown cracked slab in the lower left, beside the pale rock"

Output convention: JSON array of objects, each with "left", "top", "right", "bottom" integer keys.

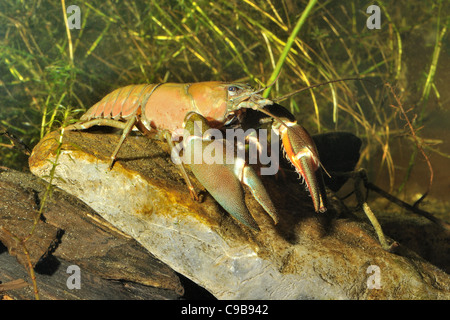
[{"left": 0, "top": 170, "right": 184, "bottom": 299}]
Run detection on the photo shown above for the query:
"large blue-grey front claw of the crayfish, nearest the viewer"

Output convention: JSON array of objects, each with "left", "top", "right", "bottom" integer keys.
[{"left": 183, "top": 113, "right": 278, "bottom": 231}]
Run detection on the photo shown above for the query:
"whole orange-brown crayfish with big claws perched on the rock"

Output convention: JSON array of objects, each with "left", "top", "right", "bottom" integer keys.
[{"left": 66, "top": 81, "right": 326, "bottom": 230}]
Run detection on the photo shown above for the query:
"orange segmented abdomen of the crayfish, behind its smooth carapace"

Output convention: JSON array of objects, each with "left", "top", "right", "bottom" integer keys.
[{"left": 80, "top": 84, "right": 158, "bottom": 121}]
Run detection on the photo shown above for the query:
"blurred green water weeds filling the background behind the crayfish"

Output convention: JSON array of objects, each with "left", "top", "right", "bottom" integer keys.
[{"left": 0, "top": 0, "right": 450, "bottom": 194}]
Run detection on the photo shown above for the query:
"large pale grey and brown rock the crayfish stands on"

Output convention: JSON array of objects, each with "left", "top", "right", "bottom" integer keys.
[{"left": 29, "top": 132, "right": 450, "bottom": 299}]
